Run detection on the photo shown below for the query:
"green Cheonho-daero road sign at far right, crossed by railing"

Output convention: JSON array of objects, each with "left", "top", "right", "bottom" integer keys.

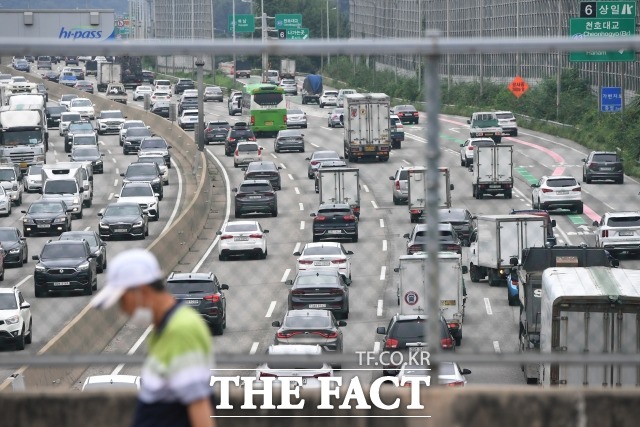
[{"left": 569, "top": 17, "right": 636, "bottom": 62}]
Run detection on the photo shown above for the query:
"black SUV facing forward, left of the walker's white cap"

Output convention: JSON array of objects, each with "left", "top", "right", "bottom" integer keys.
[{"left": 32, "top": 240, "right": 98, "bottom": 298}]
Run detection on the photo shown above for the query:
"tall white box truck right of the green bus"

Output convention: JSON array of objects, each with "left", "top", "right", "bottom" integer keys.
[{"left": 343, "top": 93, "right": 391, "bottom": 162}]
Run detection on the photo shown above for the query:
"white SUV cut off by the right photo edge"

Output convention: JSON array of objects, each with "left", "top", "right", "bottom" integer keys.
[{"left": 593, "top": 211, "right": 640, "bottom": 255}]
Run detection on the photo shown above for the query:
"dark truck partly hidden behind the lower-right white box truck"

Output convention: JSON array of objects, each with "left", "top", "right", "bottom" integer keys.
[{"left": 507, "top": 246, "right": 618, "bottom": 384}]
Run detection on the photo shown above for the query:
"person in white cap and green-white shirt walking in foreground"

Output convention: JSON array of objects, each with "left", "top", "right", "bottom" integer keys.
[{"left": 91, "top": 249, "right": 215, "bottom": 427}]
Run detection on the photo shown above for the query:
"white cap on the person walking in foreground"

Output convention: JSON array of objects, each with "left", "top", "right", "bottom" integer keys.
[{"left": 91, "top": 249, "right": 163, "bottom": 309}]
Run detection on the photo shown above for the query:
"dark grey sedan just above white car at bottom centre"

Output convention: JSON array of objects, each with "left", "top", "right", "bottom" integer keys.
[{"left": 271, "top": 309, "right": 347, "bottom": 368}]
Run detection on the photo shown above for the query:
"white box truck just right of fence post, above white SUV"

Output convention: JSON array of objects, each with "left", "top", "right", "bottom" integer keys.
[{"left": 471, "top": 145, "right": 513, "bottom": 199}]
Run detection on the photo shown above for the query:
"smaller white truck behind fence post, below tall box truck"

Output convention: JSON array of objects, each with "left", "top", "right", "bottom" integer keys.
[{"left": 407, "top": 166, "right": 454, "bottom": 222}]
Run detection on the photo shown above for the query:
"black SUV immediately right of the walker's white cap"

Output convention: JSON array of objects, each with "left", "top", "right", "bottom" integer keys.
[{"left": 167, "top": 273, "right": 229, "bottom": 335}]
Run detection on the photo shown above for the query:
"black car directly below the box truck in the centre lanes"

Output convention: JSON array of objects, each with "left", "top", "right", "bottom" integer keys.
[{"left": 311, "top": 203, "right": 358, "bottom": 242}]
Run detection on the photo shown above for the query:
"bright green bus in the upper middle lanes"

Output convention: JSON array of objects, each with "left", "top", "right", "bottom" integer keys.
[{"left": 242, "top": 83, "right": 287, "bottom": 137}]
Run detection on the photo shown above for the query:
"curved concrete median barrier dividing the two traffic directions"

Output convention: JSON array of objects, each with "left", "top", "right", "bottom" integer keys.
[{"left": 0, "top": 66, "right": 215, "bottom": 390}]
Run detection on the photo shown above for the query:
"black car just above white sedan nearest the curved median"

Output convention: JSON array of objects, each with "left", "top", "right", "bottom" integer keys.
[{"left": 231, "top": 179, "right": 278, "bottom": 218}]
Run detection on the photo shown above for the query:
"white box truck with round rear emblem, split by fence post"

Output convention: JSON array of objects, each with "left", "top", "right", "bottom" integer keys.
[{"left": 393, "top": 252, "right": 467, "bottom": 346}]
